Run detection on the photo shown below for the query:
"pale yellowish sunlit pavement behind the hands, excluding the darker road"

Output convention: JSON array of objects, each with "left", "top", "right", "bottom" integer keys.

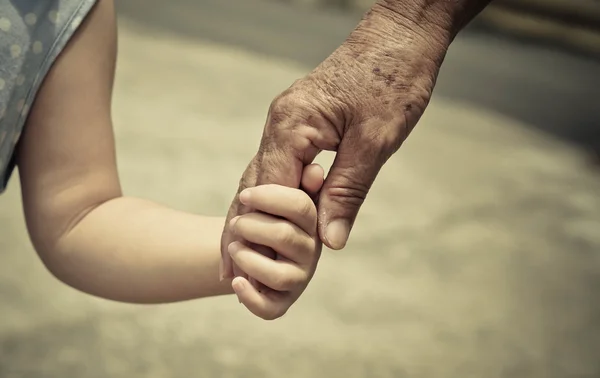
[{"left": 0, "top": 2, "right": 600, "bottom": 378}]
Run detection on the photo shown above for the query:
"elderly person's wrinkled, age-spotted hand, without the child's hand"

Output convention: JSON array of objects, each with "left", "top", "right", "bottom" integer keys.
[{"left": 221, "top": 1, "right": 488, "bottom": 277}]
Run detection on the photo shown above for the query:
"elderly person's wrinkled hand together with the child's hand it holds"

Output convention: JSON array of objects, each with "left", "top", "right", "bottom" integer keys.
[{"left": 216, "top": 0, "right": 489, "bottom": 319}]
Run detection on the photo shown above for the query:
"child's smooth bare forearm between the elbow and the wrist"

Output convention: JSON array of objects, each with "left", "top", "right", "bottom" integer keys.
[{"left": 42, "top": 197, "right": 232, "bottom": 303}]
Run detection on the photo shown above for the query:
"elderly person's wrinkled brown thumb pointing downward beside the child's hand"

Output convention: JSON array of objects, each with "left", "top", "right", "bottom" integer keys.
[{"left": 318, "top": 138, "right": 385, "bottom": 250}]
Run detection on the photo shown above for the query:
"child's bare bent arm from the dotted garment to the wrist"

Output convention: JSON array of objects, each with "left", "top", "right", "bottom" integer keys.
[{"left": 17, "top": 0, "right": 323, "bottom": 318}]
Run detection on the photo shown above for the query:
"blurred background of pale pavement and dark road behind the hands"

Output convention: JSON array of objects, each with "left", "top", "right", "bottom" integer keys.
[{"left": 0, "top": 0, "right": 600, "bottom": 378}]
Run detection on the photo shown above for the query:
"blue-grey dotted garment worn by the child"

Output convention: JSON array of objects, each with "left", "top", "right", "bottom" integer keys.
[{"left": 0, "top": 0, "right": 96, "bottom": 193}]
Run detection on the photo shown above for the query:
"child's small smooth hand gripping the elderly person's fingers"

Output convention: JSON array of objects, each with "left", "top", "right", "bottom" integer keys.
[{"left": 228, "top": 164, "right": 324, "bottom": 320}]
